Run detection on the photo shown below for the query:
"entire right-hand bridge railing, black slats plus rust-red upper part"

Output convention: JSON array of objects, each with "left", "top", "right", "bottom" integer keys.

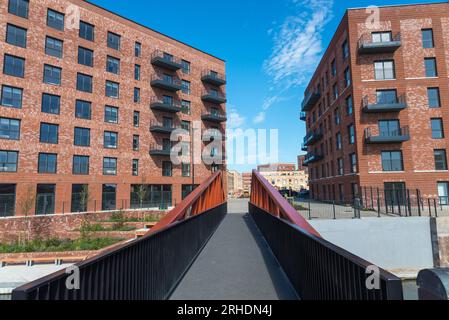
[{"left": 249, "top": 171, "right": 403, "bottom": 300}]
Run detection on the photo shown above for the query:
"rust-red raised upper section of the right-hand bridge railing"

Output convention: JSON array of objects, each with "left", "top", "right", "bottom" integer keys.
[{"left": 250, "top": 170, "right": 321, "bottom": 238}]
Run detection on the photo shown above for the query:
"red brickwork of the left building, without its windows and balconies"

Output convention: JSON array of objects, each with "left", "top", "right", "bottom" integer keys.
[{"left": 0, "top": 0, "right": 225, "bottom": 215}]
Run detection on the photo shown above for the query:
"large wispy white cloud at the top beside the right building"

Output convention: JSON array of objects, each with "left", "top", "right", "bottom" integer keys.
[{"left": 264, "top": 0, "right": 333, "bottom": 91}]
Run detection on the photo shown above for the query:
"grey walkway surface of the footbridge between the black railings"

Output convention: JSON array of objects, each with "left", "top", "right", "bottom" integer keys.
[{"left": 171, "top": 200, "right": 297, "bottom": 300}]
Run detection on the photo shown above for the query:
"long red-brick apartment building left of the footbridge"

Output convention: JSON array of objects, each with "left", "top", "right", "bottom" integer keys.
[{"left": 0, "top": 0, "right": 226, "bottom": 216}]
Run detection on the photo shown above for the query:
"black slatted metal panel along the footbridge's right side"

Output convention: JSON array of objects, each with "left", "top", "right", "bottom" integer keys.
[{"left": 249, "top": 204, "right": 403, "bottom": 300}]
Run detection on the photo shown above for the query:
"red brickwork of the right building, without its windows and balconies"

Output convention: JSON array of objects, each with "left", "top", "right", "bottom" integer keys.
[{"left": 303, "top": 3, "right": 449, "bottom": 201}]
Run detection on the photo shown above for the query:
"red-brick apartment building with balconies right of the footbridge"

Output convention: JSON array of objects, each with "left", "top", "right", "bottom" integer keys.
[{"left": 301, "top": 3, "right": 449, "bottom": 204}]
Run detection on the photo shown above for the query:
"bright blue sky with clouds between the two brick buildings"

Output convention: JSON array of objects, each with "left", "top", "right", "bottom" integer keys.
[{"left": 91, "top": 0, "right": 433, "bottom": 171}]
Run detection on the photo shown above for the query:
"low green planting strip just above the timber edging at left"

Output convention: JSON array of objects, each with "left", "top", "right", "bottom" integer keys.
[{"left": 0, "top": 238, "right": 123, "bottom": 253}]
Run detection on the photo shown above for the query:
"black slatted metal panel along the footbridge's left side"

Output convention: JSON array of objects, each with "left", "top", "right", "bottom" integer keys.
[{"left": 12, "top": 204, "right": 227, "bottom": 300}]
